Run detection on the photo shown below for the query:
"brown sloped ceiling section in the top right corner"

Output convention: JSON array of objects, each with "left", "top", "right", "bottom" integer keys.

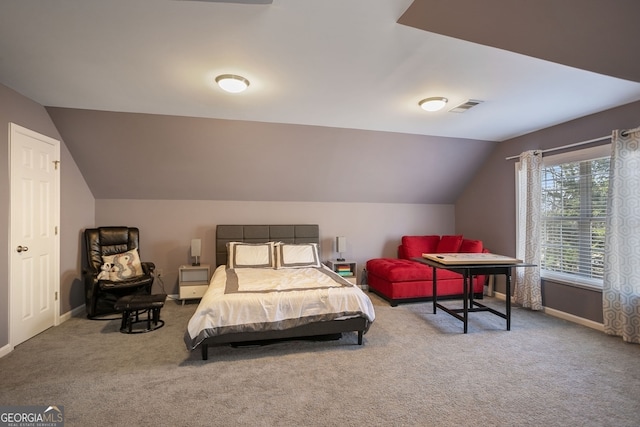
[{"left": 398, "top": 0, "right": 640, "bottom": 82}]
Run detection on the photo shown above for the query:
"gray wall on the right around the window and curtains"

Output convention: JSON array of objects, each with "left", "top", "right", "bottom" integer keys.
[{"left": 455, "top": 102, "right": 640, "bottom": 322}]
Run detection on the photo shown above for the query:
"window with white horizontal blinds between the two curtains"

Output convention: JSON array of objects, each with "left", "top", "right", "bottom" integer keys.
[{"left": 541, "top": 145, "right": 610, "bottom": 287}]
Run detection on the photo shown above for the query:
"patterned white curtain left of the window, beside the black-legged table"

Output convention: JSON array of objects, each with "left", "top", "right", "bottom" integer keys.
[{"left": 513, "top": 151, "right": 542, "bottom": 310}]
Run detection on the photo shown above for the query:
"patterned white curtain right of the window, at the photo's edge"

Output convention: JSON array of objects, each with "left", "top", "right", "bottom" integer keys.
[{"left": 602, "top": 130, "right": 640, "bottom": 343}]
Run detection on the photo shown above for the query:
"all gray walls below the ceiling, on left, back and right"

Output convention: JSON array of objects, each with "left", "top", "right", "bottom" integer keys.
[{"left": 0, "top": 78, "right": 640, "bottom": 352}]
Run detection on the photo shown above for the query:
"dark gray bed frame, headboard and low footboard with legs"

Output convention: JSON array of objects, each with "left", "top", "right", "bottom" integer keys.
[{"left": 195, "top": 224, "right": 367, "bottom": 360}]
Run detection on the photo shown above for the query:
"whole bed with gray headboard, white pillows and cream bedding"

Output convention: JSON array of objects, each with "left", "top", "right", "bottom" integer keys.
[{"left": 184, "top": 224, "right": 375, "bottom": 360}]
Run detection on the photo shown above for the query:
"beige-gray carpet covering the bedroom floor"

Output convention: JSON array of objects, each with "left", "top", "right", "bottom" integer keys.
[{"left": 0, "top": 294, "right": 640, "bottom": 427}]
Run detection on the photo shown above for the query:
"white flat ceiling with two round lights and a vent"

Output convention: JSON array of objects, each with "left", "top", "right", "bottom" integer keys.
[{"left": 0, "top": 0, "right": 640, "bottom": 141}]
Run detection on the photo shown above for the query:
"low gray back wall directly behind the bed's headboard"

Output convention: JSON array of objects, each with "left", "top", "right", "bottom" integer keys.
[{"left": 96, "top": 199, "right": 455, "bottom": 294}]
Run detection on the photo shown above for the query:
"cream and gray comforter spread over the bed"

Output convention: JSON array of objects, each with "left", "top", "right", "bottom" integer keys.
[{"left": 185, "top": 265, "right": 375, "bottom": 349}]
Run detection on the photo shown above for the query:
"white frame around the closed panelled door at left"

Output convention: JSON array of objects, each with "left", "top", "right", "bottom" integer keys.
[{"left": 7, "top": 122, "right": 62, "bottom": 350}]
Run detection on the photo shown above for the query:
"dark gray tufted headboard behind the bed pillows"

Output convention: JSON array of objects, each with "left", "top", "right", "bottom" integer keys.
[{"left": 216, "top": 224, "right": 320, "bottom": 267}]
